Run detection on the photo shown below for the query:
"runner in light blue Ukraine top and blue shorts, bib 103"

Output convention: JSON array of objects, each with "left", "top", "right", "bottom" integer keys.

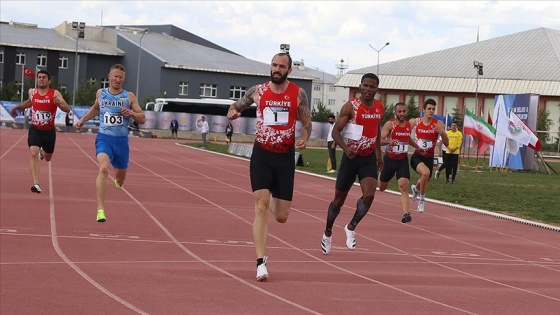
[{"left": 76, "top": 64, "right": 146, "bottom": 222}]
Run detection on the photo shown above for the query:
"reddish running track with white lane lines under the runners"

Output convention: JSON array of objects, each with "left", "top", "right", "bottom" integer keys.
[{"left": 0, "top": 129, "right": 560, "bottom": 314}]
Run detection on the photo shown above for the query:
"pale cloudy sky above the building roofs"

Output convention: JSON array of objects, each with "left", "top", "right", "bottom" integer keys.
[{"left": 0, "top": 0, "right": 560, "bottom": 74}]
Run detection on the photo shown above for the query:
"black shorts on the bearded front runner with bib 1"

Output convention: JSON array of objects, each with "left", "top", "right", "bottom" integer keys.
[{"left": 249, "top": 144, "right": 296, "bottom": 201}]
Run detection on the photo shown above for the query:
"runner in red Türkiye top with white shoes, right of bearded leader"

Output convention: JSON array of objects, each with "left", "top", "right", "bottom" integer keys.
[{"left": 321, "top": 73, "right": 383, "bottom": 255}]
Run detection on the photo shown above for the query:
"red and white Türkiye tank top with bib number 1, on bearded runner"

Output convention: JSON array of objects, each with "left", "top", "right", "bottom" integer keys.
[{"left": 255, "top": 82, "right": 300, "bottom": 153}]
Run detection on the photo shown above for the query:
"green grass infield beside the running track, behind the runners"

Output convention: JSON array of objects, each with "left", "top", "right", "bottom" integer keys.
[{"left": 189, "top": 143, "right": 560, "bottom": 226}]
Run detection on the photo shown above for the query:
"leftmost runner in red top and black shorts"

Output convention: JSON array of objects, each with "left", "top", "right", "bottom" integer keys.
[{"left": 11, "top": 70, "right": 70, "bottom": 193}]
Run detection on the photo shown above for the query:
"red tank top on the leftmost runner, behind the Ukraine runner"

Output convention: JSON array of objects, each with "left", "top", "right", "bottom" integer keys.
[{"left": 30, "top": 89, "right": 57, "bottom": 130}]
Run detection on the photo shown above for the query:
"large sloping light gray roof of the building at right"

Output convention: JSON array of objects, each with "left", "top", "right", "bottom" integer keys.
[{"left": 337, "top": 28, "right": 560, "bottom": 95}]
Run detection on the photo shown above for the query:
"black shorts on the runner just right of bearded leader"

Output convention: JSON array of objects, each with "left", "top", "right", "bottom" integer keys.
[{"left": 335, "top": 154, "right": 377, "bottom": 191}]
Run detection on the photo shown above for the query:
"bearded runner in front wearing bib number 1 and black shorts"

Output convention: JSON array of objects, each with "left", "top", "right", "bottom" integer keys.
[{"left": 228, "top": 53, "right": 311, "bottom": 281}]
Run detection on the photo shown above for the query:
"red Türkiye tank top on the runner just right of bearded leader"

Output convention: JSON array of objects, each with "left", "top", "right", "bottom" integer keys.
[{"left": 348, "top": 98, "right": 383, "bottom": 156}]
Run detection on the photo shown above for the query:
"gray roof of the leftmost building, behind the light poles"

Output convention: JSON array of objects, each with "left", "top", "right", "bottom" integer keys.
[{"left": 0, "top": 22, "right": 124, "bottom": 56}]
